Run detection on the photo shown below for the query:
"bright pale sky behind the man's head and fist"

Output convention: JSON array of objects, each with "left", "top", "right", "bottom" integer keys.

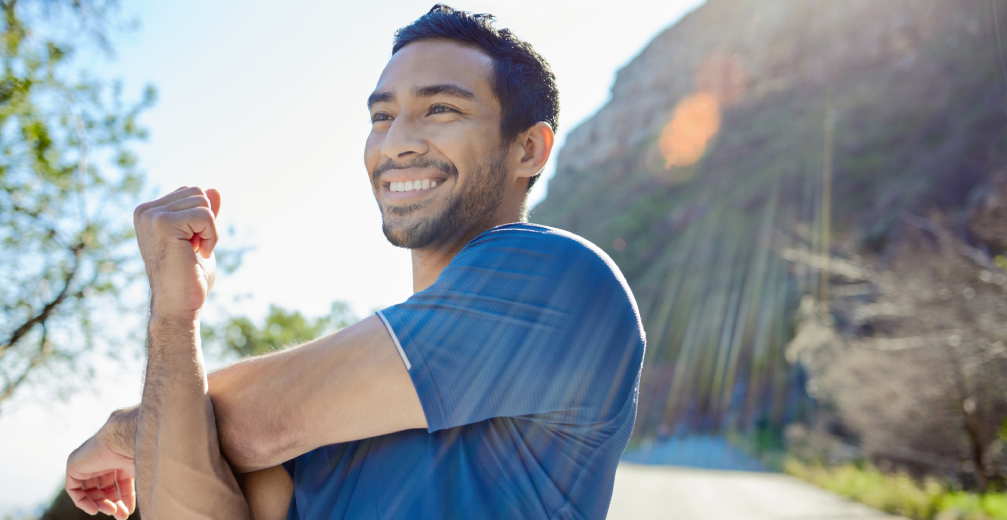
[{"left": 0, "top": 0, "right": 702, "bottom": 511}]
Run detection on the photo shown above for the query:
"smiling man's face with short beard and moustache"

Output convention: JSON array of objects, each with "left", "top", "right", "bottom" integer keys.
[{"left": 365, "top": 39, "right": 509, "bottom": 249}]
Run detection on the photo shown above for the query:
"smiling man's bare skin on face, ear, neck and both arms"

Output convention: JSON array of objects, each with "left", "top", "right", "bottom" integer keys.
[{"left": 66, "top": 40, "right": 554, "bottom": 520}]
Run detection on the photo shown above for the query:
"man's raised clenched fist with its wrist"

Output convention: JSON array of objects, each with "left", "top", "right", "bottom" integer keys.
[{"left": 133, "top": 187, "right": 221, "bottom": 318}]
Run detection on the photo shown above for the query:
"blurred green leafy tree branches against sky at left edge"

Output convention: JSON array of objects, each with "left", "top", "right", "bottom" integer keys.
[{"left": 0, "top": 0, "right": 155, "bottom": 415}]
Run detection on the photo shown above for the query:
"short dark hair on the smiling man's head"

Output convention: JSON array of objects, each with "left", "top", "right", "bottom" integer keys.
[{"left": 392, "top": 4, "right": 560, "bottom": 189}]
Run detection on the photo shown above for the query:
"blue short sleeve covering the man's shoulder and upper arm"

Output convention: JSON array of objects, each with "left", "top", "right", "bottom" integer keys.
[{"left": 379, "top": 224, "right": 643, "bottom": 431}]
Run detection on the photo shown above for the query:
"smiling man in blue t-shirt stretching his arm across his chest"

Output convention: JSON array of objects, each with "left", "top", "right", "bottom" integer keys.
[{"left": 66, "top": 5, "right": 643, "bottom": 520}]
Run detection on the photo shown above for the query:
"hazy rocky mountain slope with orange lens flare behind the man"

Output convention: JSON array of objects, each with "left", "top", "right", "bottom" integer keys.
[{"left": 531, "top": 0, "right": 1007, "bottom": 447}]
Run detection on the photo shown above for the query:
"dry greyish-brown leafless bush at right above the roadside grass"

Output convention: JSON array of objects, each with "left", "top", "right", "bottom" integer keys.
[{"left": 786, "top": 210, "right": 1007, "bottom": 491}]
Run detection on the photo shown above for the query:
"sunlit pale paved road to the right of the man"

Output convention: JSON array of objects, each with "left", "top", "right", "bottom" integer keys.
[{"left": 608, "top": 464, "right": 899, "bottom": 520}]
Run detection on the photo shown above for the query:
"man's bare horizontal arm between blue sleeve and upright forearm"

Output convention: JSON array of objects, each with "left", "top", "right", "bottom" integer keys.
[{"left": 209, "top": 315, "right": 427, "bottom": 473}]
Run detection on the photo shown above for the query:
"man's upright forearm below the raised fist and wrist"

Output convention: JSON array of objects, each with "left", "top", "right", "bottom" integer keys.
[{"left": 134, "top": 316, "right": 249, "bottom": 520}]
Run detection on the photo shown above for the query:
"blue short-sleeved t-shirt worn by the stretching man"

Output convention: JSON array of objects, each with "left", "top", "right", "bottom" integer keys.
[{"left": 284, "top": 224, "right": 644, "bottom": 520}]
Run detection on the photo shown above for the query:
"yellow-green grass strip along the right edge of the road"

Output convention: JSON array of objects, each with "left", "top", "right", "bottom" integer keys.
[{"left": 783, "top": 458, "right": 1007, "bottom": 520}]
